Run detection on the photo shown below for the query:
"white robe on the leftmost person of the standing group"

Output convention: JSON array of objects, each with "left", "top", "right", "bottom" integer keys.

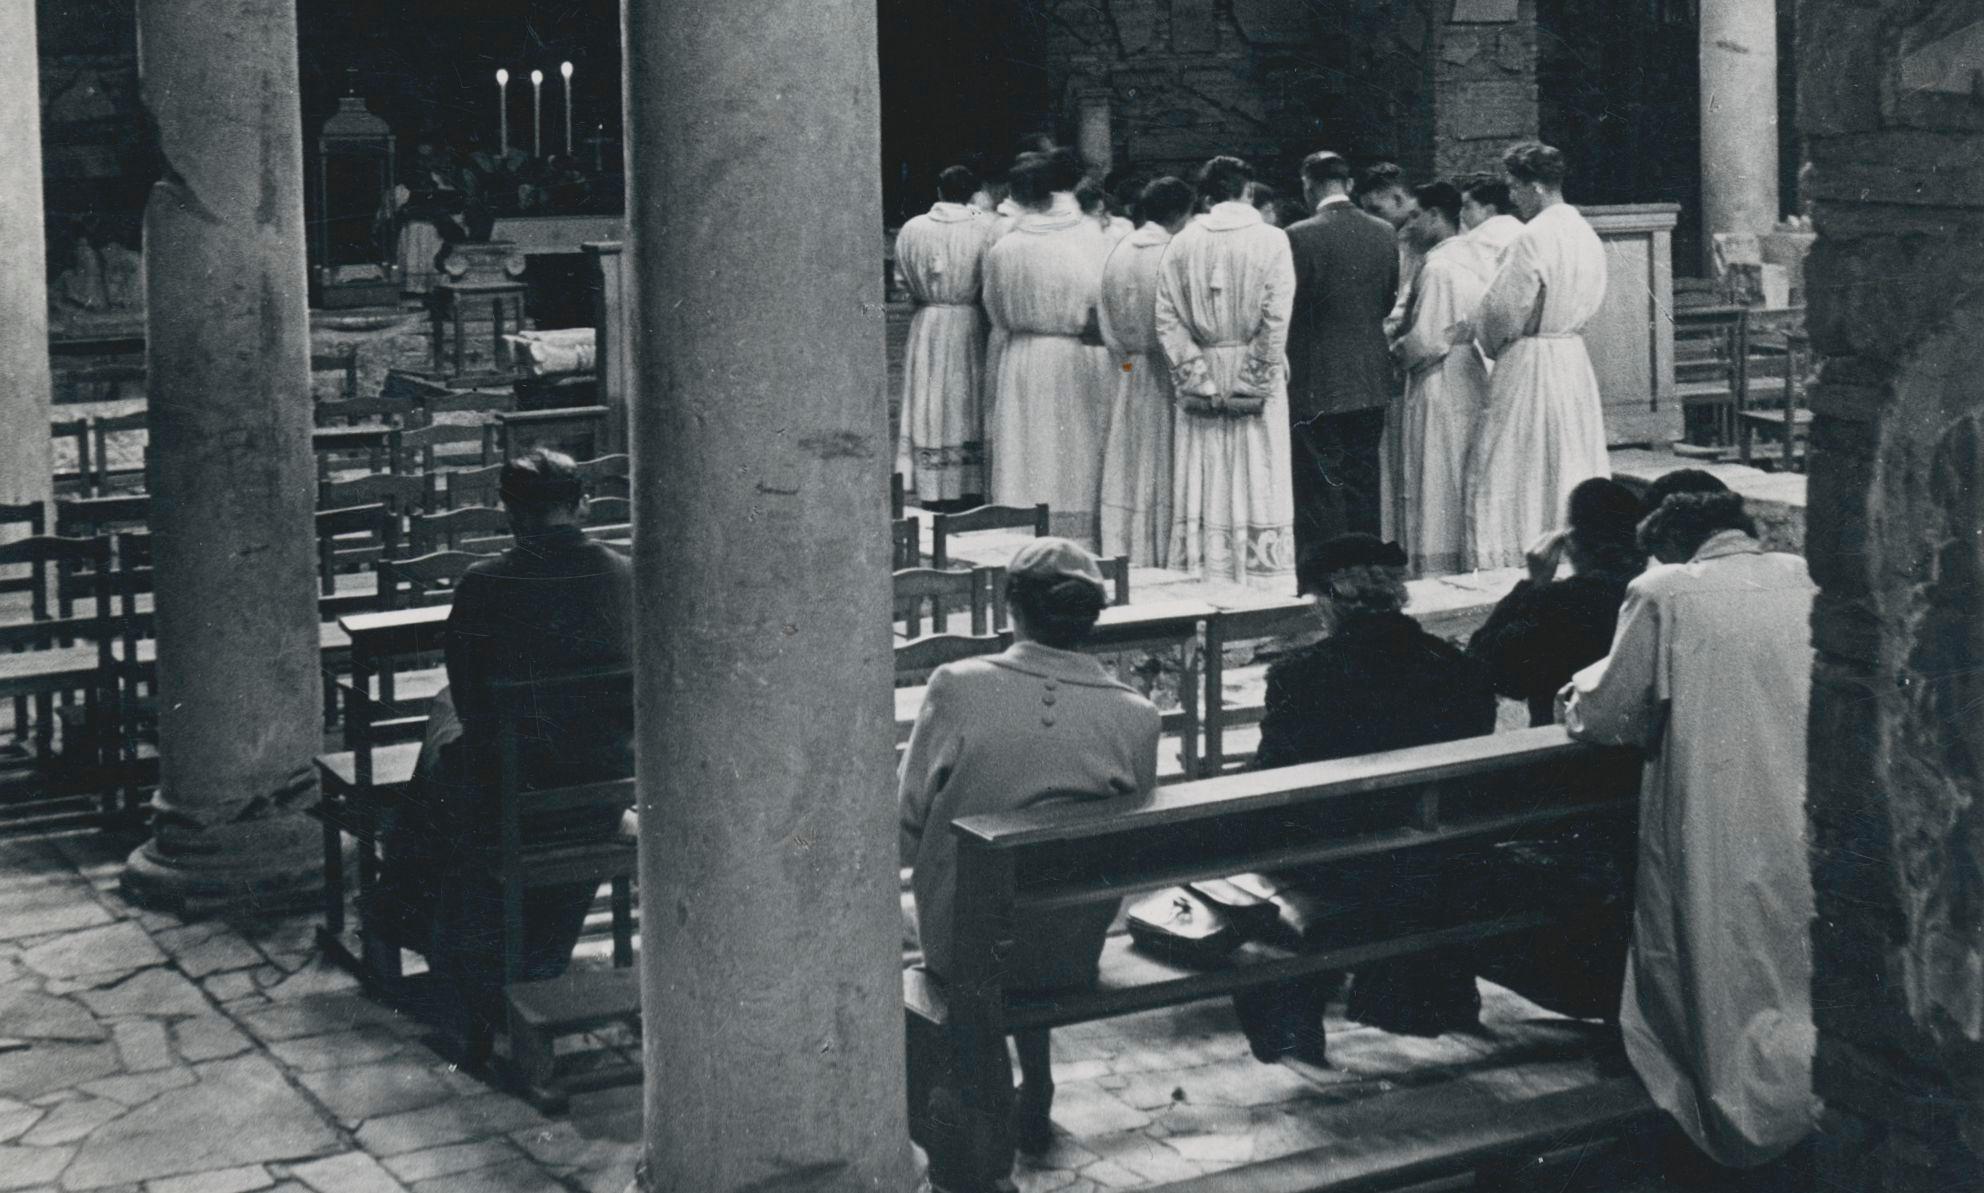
[{"left": 895, "top": 202, "right": 992, "bottom": 500}]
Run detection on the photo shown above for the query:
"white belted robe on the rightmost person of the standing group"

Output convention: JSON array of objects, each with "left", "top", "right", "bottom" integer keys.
[{"left": 1468, "top": 202, "right": 1611, "bottom": 568}]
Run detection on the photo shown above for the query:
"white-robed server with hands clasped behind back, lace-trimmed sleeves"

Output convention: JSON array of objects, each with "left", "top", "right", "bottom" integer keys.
[{"left": 1157, "top": 157, "right": 1296, "bottom": 592}]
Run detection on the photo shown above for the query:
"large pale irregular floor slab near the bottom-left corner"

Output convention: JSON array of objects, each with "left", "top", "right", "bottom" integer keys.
[{"left": 62, "top": 1056, "right": 339, "bottom": 1189}]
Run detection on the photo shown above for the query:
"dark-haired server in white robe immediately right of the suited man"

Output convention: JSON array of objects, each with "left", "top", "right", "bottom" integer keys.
[{"left": 1389, "top": 183, "right": 1488, "bottom": 576}]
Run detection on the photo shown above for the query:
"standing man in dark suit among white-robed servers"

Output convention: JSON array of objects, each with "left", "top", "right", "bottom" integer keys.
[{"left": 1288, "top": 153, "right": 1399, "bottom": 575}]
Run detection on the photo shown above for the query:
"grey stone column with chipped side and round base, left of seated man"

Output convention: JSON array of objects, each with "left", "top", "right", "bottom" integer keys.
[{"left": 125, "top": 0, "right": 323, "bottom": 909}]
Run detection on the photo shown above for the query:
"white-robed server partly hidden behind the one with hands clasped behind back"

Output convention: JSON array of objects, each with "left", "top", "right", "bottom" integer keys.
[{"left": 1099, "top": 177, "right": 1194, "bottom": 568}]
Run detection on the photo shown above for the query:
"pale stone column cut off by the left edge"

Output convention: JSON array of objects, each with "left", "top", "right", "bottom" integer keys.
[{"left": 0, "top": 4, "right": 54, "bottom": 534}]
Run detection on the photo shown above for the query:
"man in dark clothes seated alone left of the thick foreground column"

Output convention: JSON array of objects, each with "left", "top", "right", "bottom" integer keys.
[{"left": 367, "top": 449, "right": 633, "bottom": 1054}]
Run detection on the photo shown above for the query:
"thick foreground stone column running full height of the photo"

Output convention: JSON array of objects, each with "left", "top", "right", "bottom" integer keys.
[{"left": 623, "top": 0, "right": 917, "bottom": 1193}]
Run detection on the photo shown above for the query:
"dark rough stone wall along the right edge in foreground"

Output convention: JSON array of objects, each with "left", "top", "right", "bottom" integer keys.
[{"left": 1798, "top": 0, "right": 1984, "bottom": 1191}]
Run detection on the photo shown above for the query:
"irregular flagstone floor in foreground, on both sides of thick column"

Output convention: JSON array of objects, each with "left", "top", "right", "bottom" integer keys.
[{"left": 0, "top": 817, "right": 1690, "bottom": 1193}]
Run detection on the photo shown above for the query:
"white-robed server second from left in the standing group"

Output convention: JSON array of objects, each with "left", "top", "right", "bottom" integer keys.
[{"left": 984, "top": 151, "right": 1109, "bottom": 546}]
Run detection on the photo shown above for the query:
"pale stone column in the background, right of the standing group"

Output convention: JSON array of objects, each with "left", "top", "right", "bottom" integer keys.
[{"left": 1698, "top": 0, "right": 1777, "bottom": 260}]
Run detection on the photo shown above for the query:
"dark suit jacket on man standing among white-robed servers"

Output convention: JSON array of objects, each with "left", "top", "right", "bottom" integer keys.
[{"left": 1288, "top": 204, "right": 1399, "bottom": 423}]
